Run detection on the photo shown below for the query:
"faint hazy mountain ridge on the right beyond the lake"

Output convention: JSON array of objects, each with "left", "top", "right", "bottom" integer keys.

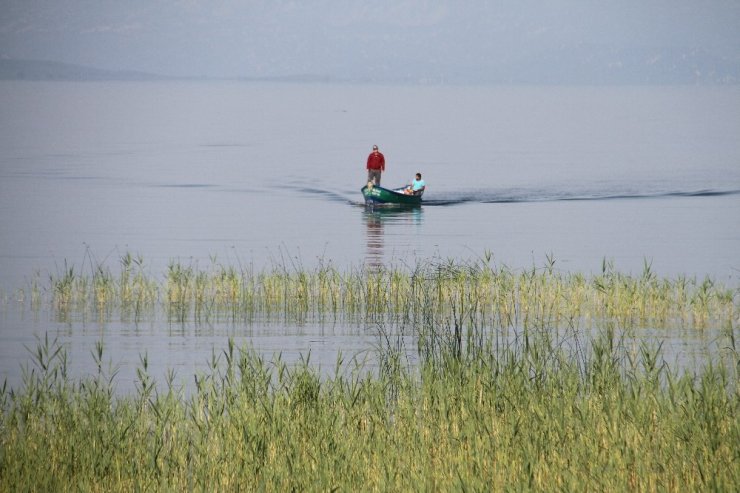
[{"left": 340, "top": 44, "right": 740, "bottom": 85}]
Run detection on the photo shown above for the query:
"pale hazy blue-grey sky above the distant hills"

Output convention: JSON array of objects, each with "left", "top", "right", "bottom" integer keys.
[{"left": 0, "top": 0, "right": 740, "bottom": 78}]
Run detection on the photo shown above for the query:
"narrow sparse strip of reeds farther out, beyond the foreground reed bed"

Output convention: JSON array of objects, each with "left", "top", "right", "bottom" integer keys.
[{"left": 31, "top": 255, "right": 740, "bottom": 328}]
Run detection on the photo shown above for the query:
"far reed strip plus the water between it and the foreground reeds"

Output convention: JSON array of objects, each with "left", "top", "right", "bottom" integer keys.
[{"left": 0, "top": 254, "right": 740, "bottom": 393}]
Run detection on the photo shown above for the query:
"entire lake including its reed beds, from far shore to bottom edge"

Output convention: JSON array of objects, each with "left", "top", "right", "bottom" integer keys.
[{"left": 0, "top": 82, "right": 740, "bottom": 491}]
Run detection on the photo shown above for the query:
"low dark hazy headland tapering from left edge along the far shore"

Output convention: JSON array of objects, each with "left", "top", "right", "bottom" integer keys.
[{"left": 0, "top": 59, "right": 166, "bottom": 81}]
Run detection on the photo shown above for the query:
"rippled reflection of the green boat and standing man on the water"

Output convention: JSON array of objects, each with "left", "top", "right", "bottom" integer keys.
[{"left": 362, "top": 206, "right": 423, "bottom": 268}]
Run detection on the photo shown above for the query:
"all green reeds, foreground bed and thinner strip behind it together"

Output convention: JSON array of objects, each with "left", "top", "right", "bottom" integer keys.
[{"left": 0, "top": 256, "right": 740, "bottom": 491}]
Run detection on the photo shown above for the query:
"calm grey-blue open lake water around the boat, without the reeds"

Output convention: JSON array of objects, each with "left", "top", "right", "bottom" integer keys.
[{"left": 0, "top": 82, "right": 740, "bottom": 392}]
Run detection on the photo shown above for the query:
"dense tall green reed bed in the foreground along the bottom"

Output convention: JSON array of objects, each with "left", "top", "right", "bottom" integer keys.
[{"left": 0, "top": 330, "right": 740, "bottom": 491}]
